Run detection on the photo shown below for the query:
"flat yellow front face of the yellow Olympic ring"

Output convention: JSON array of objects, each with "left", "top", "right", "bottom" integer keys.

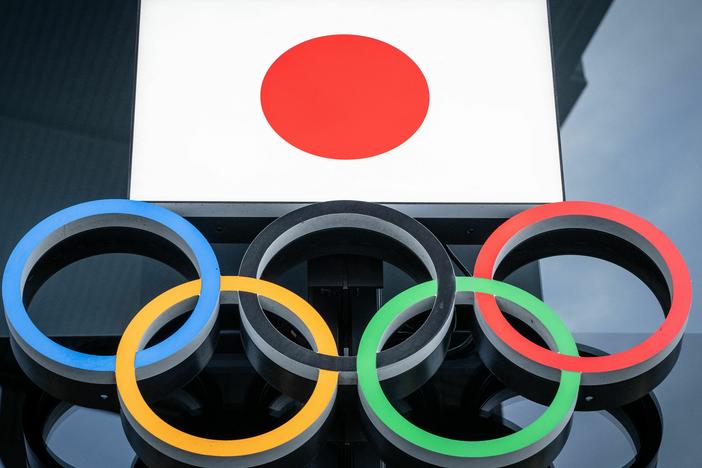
[{"left": 115, "top": 276, "right": 339, "bottom": 457}]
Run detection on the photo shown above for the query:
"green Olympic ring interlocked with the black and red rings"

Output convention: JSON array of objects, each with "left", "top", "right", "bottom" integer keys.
[{"left": 358, "top": 277, "right": 580, "bottom": 467}]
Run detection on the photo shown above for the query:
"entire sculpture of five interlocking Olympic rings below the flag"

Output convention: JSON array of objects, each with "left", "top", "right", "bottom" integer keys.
[{"left": 2, "top": 200, "right": 691, "bottom": 466}]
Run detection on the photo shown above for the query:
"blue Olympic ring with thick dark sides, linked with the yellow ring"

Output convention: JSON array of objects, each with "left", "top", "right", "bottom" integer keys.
[{"left": 2, "top": 200, "right": 219, "bottom": 407}]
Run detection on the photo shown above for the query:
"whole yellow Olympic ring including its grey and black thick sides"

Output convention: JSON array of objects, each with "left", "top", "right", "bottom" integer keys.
[{"left": 116, "top": 276, "right": 338, "bottom": 466}]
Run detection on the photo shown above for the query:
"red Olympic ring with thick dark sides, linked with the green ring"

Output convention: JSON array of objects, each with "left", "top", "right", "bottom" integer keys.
[{"left": 475, "top": 202, "right": 692, "bottom": 409}]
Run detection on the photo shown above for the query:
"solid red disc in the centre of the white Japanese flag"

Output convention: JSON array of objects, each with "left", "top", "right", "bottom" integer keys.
[{"left": 261, "top": 34, "right": 429, "bottom": 159}]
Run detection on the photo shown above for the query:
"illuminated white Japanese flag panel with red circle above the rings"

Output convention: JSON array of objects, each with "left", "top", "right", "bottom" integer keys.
[{"left": 130, "top": 0, "right": 563, "bottom": 203}]
